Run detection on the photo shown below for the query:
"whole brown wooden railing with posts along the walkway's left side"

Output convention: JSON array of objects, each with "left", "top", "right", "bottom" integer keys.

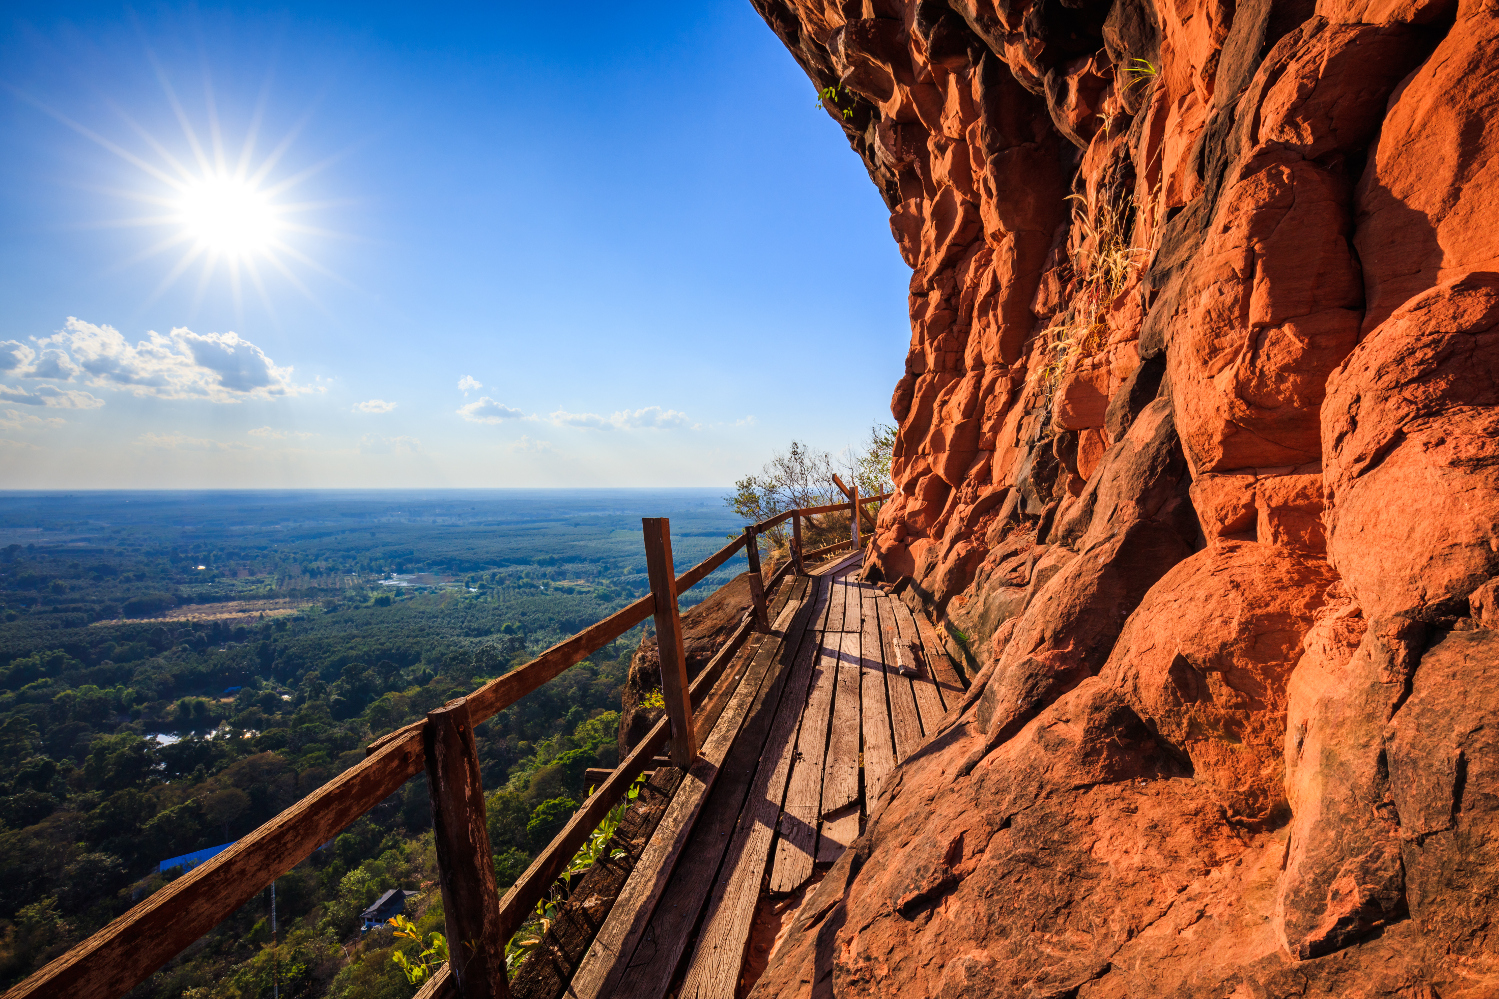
[{"left": 4, "top": 482, "right": 889, "bottom": 999}]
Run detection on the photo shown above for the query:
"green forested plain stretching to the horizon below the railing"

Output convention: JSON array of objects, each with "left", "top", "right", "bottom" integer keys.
[{"left": 0, "top": 491, "right": 742, "bottom": 999}]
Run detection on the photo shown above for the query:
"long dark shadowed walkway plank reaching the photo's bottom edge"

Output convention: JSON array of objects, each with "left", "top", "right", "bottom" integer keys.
[{"left": 612, "top": 576, "right": 814, "bottom": 999}]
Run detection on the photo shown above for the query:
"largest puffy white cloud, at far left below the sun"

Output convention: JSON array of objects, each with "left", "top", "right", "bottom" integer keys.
[{"left": 19, "top": 317, "right": 310, "bottom": 402}]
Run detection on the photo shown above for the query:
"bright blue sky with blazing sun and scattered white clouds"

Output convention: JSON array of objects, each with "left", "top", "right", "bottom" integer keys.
[{"left": 0, "top": 0, "right": 910, "bottom": 489}]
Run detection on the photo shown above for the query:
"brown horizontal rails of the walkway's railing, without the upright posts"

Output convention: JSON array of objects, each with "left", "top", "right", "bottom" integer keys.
[{"left": 3, "top": 497, "right": 845, "bottom": 999}]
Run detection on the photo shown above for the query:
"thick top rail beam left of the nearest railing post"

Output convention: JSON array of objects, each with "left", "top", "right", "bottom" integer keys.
[{"left": 6, "top": 729, "right": 424, "bottom": 999}]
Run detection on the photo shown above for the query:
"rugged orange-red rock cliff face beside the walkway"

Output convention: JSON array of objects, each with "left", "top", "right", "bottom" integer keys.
[{"left": 751, "top": 0, "right": 1499, "bottom": 999}]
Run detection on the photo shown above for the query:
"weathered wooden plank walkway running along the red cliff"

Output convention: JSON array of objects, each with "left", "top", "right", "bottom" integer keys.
[{"left": 527, "top": 555, "right": 962, "bottom": 999}]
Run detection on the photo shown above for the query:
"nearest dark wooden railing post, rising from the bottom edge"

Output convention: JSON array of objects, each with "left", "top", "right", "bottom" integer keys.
[{"left": 423, "top": 698, "right": 510, "bottom": 999}]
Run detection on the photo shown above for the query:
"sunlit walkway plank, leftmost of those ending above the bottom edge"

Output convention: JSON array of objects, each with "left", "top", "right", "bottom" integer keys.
[{"left": 770, "top": 615, "right": 842, "bottom": 893}]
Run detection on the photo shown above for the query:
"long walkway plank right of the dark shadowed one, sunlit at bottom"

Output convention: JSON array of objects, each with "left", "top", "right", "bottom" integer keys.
[{"left": 678, "top": 573, "right": 821, "bottom": 999}]
